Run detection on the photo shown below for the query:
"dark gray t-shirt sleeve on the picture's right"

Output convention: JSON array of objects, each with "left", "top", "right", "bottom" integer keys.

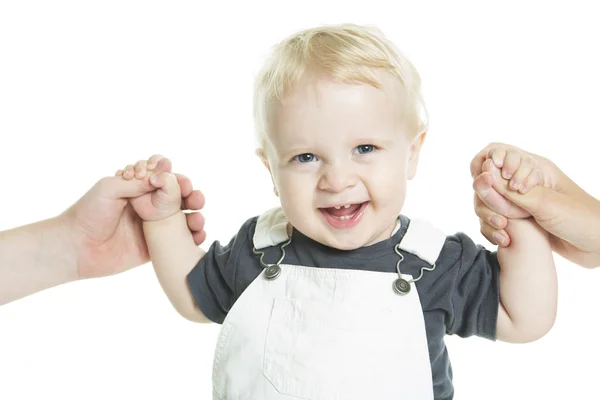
[{"left": 442, "top": 233, "right": 500, "bottom": 340}]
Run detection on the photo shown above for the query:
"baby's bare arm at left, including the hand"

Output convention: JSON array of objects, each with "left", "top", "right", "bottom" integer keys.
[{"left": 122, "top": 158, "right": 209, "bottom": 322}]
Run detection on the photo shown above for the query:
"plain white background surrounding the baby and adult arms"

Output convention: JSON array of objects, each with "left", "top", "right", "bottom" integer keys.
[{"left": 0, "top": 0, "right": 600, "bottom": 400}]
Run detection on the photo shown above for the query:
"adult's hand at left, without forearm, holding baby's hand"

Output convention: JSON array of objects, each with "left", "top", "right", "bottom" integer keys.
[{"left": 59, "top": 155, "right": 206, "bottom": 278}]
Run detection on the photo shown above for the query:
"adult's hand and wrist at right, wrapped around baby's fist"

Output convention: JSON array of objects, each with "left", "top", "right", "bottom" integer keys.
[{"left": 471, "top": 143, "right": 600, "bottom": 267}]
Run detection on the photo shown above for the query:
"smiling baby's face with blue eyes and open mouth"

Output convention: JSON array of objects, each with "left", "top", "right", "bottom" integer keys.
[{"left": 266, "top": 71, "right": 424, "bottom": 250}]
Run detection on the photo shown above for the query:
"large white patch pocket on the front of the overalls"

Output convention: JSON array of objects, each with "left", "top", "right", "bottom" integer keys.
[{"left": 263, "top": 299, "right": 397, "bottom": 400}]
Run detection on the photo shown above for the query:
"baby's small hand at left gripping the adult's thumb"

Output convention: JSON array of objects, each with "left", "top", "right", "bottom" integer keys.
[{"left": 115, "top": 155, "right": 181, "bottom": 221}]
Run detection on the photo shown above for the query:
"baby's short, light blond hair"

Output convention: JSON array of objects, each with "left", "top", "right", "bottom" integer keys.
[{"left": 254, "top": 24, "right": 428, "bottom": 151}]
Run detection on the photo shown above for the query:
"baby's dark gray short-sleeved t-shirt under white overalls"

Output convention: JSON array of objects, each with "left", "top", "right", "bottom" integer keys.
[{"left": 187, "top": 216, "right": 500, "bottom": 400}]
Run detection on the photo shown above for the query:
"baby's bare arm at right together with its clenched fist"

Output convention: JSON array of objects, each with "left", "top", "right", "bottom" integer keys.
[{"left": 471, "top": 146, "right": 558, "bottom": 342}]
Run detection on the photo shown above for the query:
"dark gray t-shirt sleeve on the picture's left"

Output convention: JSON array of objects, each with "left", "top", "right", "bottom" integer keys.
[{"left": 187, "top": 217, "right": 257, "bottom": 324}]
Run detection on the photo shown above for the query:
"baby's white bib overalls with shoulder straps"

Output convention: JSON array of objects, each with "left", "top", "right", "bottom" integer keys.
[{"left": 213, "top": 208, "right": 445, "bottom": 400}]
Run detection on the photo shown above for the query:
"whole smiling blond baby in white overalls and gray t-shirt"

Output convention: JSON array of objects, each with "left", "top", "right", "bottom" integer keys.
[{"left": 120, "top": 24, "right": 557, "bottom": 400}]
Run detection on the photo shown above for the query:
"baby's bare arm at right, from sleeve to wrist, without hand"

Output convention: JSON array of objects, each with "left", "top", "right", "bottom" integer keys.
[{"left": 497, "top": 198, "right": 558, "bottom": 343}]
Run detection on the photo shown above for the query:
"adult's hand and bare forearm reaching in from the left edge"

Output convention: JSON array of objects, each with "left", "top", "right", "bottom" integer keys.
[{"left": 0, "top": 156, "right": 206, "bottom": 305}]
